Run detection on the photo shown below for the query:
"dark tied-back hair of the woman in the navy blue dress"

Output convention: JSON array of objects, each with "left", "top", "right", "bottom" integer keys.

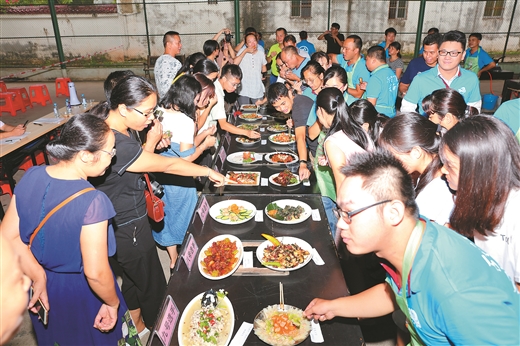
[{"left": 46, "top": 113, "right": 110, "bottom": 161}]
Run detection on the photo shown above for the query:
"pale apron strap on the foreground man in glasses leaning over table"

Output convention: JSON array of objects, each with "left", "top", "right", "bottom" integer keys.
[{"left": 395, "top": 220, "right": 424, "bottom": 346}]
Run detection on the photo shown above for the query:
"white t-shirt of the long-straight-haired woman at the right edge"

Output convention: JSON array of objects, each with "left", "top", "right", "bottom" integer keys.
[{"left": 475, "top": 190, "right": 520, "bottom": 282}]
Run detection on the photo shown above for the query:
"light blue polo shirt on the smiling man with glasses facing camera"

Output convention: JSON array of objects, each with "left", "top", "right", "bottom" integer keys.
[{"left": 404, "top": 66, "right": 482, "bottom": 114}]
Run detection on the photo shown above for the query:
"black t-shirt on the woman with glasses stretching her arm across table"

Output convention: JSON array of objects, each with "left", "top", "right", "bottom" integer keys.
[{"left": 92, "top": 130, "right": 146, "bottom": 225}]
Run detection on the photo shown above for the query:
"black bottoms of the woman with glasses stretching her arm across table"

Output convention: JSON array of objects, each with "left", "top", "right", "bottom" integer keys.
[{"left": 115, "top": 216, "right": 166, "bottom": 327}]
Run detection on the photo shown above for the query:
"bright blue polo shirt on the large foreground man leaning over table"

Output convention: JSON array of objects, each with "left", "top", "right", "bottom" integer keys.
[{"left": 383, "top": 217, "right": 520, "bottom": 345}]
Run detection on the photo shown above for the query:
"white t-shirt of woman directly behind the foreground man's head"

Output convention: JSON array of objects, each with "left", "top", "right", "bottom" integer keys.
[{"left": 415, "top": 176, "right": 455, "bottom": 225}]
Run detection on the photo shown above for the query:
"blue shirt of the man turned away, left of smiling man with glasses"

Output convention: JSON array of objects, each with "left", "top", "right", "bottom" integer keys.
[{"left": 366, "top": 64, "right": 399, "bottom": 118}]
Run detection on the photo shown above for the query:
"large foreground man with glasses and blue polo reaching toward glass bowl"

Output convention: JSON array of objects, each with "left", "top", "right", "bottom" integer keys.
[{"left": 305, "top": 151, "right": 520, "bottom": 345}]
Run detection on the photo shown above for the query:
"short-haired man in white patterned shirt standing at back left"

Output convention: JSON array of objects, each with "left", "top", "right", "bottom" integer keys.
[{"left": 153, "top": 31, "right": 182, "bottom": 98}]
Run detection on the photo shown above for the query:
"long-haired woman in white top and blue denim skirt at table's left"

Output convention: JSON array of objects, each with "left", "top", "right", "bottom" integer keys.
[{"left": 153, "top": 75, "right": 215, "bottom": 269}]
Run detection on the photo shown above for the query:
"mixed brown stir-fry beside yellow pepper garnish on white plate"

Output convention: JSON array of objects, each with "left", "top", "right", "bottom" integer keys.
[{"left": 262, "top": 243, "right": 310, "bottom": 269}]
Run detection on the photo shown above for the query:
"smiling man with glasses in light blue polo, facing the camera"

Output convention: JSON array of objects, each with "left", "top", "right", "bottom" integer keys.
[{"left": 401, "top": 30, "right": 482, "bottom": 114}]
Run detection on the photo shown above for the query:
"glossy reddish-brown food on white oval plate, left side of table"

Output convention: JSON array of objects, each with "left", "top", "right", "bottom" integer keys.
[{"left": 201, "top": 238, "right": 239, "bottom": 277}]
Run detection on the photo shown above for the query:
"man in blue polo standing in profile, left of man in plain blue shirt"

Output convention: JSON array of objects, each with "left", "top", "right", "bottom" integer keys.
[{"left": 329, "top": 35, "right": 370, "bottom": 106}]
